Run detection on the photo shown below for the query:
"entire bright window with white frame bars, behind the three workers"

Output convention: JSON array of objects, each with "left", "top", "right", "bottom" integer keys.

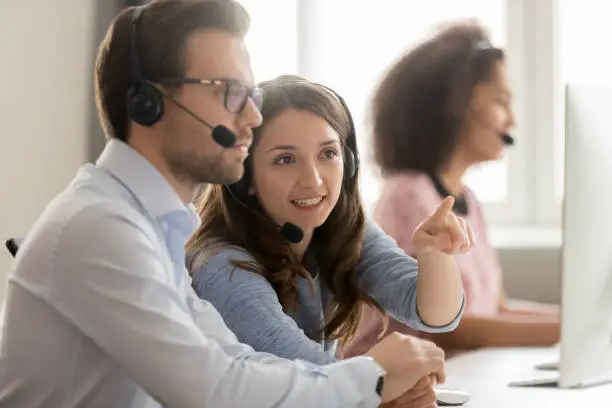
[{"left": 240, "top": 0, "right": 568, "bottom": 228}]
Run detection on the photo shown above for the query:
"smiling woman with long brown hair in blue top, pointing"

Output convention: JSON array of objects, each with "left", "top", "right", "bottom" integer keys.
[{"left": 187, "top": 76, "right": 471, "bottom": 404}]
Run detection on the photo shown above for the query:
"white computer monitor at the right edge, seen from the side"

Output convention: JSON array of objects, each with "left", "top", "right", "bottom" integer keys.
[{"left": 558, "top": 85, "right": 612, "bottom": 388}]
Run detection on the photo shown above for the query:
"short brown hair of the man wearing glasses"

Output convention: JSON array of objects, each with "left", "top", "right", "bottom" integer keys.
[{"left": 95, "top": 0, "right": 249, "bottom": 141}]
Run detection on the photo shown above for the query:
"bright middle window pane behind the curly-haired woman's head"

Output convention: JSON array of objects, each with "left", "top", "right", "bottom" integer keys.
[{"left": 300, "top": 0, "right": 510, "bottom": 215}]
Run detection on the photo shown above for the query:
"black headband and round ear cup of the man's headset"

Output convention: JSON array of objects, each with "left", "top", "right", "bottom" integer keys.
[{"left": 126, "top": 6, "right": 164, "bottom": 126}]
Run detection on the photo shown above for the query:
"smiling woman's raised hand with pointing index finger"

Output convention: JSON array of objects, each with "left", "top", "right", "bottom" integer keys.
[{"left": 412, "top": 196, "right": 474, "bottom": 254}]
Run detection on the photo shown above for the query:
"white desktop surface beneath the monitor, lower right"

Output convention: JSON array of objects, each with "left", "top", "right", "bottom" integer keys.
[{"left": 443, "top": 348, "right": 612, "bottom": 408}]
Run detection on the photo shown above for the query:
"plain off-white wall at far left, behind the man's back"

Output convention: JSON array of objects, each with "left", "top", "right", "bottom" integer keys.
[{"left": 0, "top": 0, "right": 103, "bottom": 295}]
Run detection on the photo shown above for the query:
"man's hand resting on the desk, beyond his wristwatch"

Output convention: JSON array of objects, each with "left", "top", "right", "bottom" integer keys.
[{"left": 366, "top": 333, "right": 446, "bottom": 402}]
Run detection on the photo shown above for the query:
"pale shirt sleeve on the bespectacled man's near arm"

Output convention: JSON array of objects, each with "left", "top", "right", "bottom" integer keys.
[{"left": 35, "top": 206, "right": 384, "bottom": 408}]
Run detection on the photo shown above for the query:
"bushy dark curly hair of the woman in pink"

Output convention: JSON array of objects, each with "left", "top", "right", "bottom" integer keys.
[{"left": 372, "top": 20, "right": 504, "bottom": 175}]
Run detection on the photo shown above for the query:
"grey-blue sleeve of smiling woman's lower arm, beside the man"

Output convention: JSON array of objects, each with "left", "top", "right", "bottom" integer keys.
[{"left": 193, "top": 247, "right": 334, "bottom": 364}]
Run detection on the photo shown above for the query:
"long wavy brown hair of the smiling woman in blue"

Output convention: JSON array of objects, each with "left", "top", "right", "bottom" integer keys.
[{"left": 187, "top": 75, "right": 379, "bottom": 340}]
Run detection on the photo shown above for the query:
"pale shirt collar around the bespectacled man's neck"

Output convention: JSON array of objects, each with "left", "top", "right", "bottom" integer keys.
[{"left": 96, "top": 139, "right": 200, "bottom": 234}]
